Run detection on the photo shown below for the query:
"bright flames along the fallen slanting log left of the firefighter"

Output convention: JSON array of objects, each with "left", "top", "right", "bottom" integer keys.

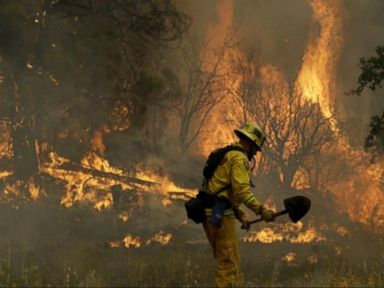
[{"left": 40, "top": 147, "right": 197, "bottom": 210}]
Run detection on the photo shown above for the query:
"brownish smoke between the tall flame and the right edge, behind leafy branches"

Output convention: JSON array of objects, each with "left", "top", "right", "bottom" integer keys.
[{"left": 336, "top": 1, "right": 384, "bottom": 143}]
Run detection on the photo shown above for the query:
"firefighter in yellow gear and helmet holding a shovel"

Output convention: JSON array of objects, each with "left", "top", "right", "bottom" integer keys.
[{"left": 203, "top": 123, "right": 274, "bottom": 287}]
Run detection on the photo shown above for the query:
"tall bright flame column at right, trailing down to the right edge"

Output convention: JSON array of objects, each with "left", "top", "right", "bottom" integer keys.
[{"left": 296, "top": 0, "right": 384, "bottom": 233}]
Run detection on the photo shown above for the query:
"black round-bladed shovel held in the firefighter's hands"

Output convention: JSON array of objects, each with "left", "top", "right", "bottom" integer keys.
[{"left": 248, "top": 196, "right": 311, "bottom": 225}]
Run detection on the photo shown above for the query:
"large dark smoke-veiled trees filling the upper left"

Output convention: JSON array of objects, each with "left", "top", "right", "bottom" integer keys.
[{"left": 0, "top": 0, "right": 190, "bottom": 200}]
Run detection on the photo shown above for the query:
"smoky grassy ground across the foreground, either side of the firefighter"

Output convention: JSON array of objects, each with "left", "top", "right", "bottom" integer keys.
[{"left": 0, "top": 192, "right": 384, "bottom": 287}]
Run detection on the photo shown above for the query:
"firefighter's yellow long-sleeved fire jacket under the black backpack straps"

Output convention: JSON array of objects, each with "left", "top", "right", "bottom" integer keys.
[{"left": 205, "top": 143, "right": 261, "bottom": 220}]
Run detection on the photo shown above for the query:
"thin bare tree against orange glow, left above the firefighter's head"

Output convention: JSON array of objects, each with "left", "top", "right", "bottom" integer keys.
[{"left": 178, "top": 39, "right": 227, "bottom": 151}]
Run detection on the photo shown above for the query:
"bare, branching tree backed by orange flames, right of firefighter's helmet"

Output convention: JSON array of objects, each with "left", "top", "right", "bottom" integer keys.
[{"left": 228, "top": 48, "right": 335, "bottom": 194}]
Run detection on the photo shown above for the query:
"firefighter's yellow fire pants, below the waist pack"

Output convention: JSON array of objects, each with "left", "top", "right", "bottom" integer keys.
[{"left": 203, "top": 216, "right": 242, "bottom": 287}]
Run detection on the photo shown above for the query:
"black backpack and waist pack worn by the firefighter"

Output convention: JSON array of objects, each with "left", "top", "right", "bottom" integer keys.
[{"left": 184, "top": 145, "right": 245, "bottom": 223}]
